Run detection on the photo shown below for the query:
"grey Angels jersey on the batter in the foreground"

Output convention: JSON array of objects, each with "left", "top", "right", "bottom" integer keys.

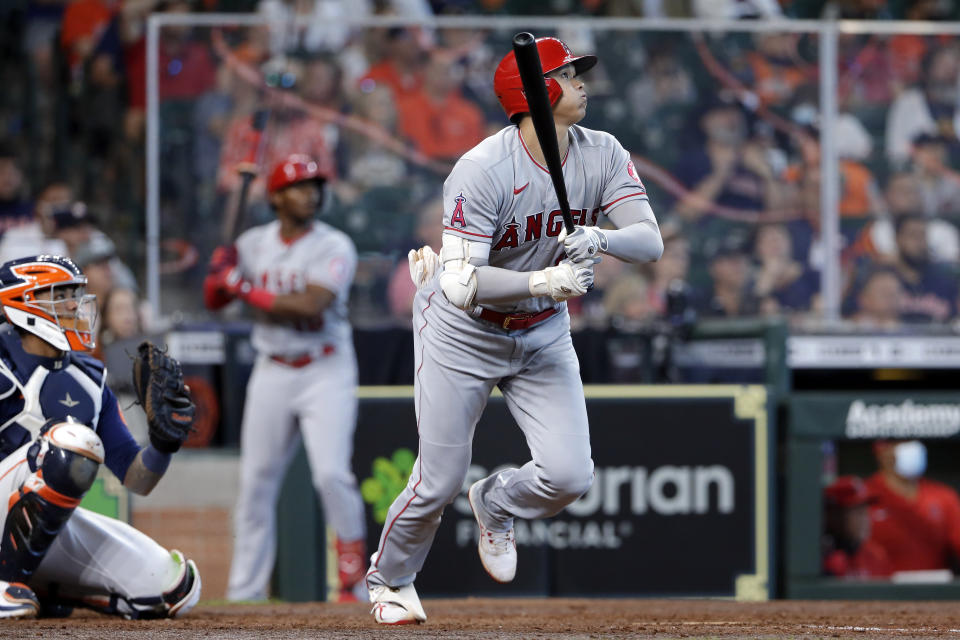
[{"left": 443, "top": 125, "right": 647, "bottom": 312}]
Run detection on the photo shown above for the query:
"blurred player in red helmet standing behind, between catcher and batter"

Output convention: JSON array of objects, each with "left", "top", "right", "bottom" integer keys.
[{"left": 204, "top": 154, "right": 366, "bottom": 601}]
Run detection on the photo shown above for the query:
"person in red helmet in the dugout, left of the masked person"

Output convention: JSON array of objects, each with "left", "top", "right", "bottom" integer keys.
[{"left": 822, "top": 476, "right": 890, "bottom": 578}]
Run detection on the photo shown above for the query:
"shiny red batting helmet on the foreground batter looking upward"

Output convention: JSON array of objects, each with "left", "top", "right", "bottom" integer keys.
[{"left": 493, "top": 38, "right": 597, "bottom": 122}]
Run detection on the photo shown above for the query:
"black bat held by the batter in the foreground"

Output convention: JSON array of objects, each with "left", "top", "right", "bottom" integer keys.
[{"left": 513, "top": 31, "right": 573, "bottom": 233}]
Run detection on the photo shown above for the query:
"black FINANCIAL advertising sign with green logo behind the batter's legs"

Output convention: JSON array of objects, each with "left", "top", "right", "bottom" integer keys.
[{"left": 354, "top": 385, "right": 769, "bottom": 599}]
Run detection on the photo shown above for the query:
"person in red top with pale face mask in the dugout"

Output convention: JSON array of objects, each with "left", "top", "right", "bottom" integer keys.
[{"left": 866, "top": 440, "right": 960, "bottom": 572}]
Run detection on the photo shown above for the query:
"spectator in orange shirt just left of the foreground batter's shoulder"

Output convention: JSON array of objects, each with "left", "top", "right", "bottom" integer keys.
[{"left": 397, "top": 51, "right": 485, "bottom": 159}]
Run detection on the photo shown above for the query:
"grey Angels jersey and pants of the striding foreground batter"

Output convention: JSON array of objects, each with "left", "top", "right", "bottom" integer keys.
[{"left": 368, "top": 126, "right": 647, "bottom": 587}]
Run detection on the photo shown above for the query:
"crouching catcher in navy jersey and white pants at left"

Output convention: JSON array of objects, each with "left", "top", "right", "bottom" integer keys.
[{"left": 0, "top": 255, "right": 201, "bottom": 618}]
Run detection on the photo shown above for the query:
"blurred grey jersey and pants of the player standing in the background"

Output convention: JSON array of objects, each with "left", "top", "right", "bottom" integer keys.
[{"left": 227, "top": 221, "right": 365, "bottom": 600}]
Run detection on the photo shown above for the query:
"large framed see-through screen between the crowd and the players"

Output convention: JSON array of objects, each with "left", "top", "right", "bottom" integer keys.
[{"left": 150, "top": 16, "right": 960, "bottom": 329}]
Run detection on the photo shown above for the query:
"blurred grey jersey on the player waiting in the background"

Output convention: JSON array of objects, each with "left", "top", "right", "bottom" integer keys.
[{"left": 236, "top": 221, "right": 357, "bottom": 356}]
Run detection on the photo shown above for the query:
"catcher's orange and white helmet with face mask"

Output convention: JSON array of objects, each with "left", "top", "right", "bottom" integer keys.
[{"left": 0, "top": 255, "right": 97, "bottom": 351}]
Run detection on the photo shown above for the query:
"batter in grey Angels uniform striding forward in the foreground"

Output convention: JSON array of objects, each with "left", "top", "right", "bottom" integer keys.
[{"left": 367, "top": 38, "right": 663, "bottom": 624}]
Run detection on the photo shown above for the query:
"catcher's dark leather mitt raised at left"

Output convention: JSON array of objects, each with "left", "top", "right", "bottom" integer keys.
[{"left": 133, "top": 340, "right": 195, "bottom": 453}]
